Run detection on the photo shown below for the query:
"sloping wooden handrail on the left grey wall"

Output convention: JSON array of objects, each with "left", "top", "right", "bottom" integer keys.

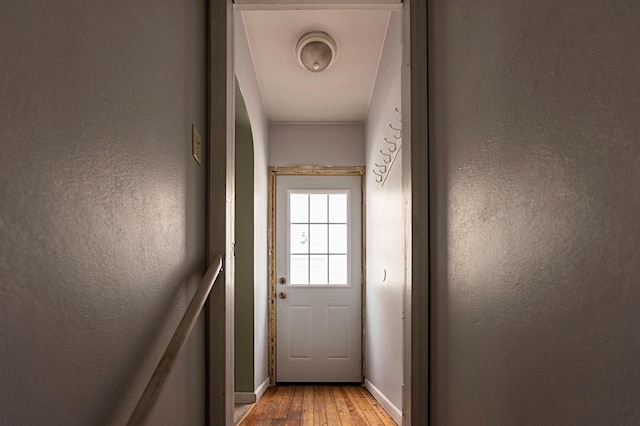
[{"left": 127, "top": 254, "right": 222, "bottom": 426}]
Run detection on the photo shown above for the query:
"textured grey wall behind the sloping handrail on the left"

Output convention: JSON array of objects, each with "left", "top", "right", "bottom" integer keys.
[{"left": 0, "top": 0, "right": 206, "bottom": 425}]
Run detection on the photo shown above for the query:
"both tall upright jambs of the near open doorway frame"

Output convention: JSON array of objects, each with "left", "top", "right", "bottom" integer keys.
[{"left": 211, "top": 0, "right": 431, "bottom": 425}]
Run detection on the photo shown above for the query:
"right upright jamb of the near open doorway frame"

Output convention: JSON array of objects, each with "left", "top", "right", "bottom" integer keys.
[{"left": 401, "top": 0, "right": 431, "bottom": 425}]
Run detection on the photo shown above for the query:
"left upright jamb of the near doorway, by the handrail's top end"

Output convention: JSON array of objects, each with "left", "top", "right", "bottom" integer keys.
[{"left": 205, "top": 0, "right": 235, "bottom": 426}]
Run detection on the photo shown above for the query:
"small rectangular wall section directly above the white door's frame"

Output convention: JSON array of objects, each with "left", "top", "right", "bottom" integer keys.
[{"left": 269, "top": 124, "right": 364, "bottom": 166}]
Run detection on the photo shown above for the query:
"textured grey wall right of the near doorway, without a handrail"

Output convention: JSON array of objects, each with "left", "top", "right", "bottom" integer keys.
[{"left": 428, "top": 0, "right": 640, "bottom": 425}]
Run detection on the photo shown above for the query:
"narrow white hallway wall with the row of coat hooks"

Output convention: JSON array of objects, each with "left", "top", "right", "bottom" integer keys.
[{"left": 365, "top": 12, "right": 404, "bottom": 420}]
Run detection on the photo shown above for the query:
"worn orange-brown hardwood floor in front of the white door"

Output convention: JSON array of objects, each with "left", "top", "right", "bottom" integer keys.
[{"left": 239, "top": 385, "right": 396, "bottom": 426}]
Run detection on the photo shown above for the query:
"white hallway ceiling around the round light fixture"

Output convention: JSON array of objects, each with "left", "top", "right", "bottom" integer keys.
[{"left": 238, "top": 6, "right": 391, "bottom": 123}]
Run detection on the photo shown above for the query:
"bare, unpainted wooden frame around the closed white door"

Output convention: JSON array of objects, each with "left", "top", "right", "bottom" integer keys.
[{"left": 267, "top": 166, "right": 366, "bottom": 386}]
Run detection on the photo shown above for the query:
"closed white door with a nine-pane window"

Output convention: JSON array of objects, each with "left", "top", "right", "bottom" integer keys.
[{"left": 275, "top": 176, "right": 362, "bottom": 382}]
